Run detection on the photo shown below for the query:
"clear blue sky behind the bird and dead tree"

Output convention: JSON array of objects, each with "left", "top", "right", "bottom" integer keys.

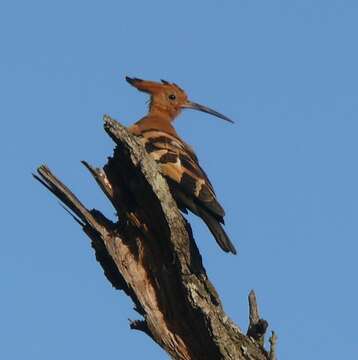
[{"left": 0, "top": 0, "right": 358, "bottom": 360}]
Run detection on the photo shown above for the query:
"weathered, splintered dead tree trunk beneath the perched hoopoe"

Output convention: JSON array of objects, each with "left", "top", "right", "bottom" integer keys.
[{"left": 35, "top": 116, "right": 273, "bottom": 360}]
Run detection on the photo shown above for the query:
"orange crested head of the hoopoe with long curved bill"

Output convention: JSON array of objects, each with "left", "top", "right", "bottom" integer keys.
[{"left": 126, "top": 76, "right": 233, "bottom": 123}]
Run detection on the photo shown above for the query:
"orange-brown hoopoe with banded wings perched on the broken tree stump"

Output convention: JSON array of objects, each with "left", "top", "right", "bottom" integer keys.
[{"left": 126, "top": 77, "right": 236, "bottom": 254}]
